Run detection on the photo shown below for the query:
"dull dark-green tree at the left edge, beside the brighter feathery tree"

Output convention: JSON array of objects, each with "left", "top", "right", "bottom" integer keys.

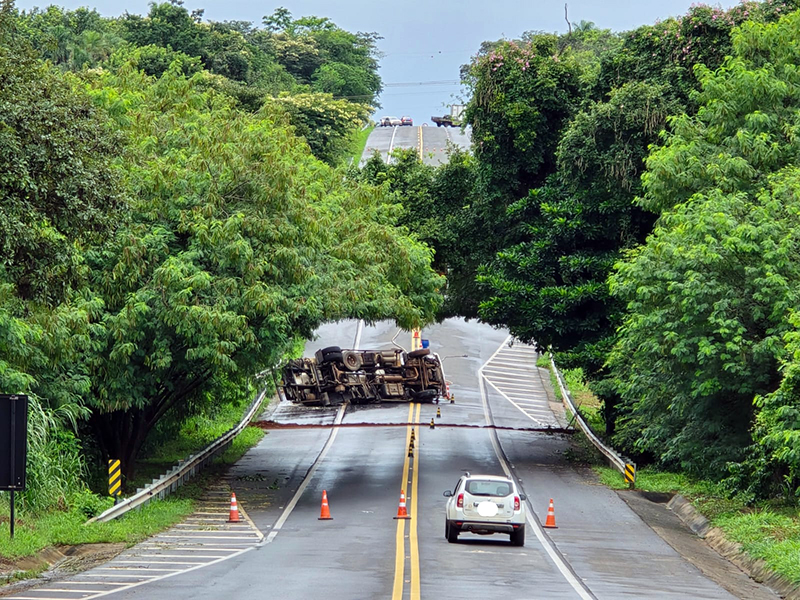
[{"left": 0, "top": 21, "right": 123, "bottom": 306}]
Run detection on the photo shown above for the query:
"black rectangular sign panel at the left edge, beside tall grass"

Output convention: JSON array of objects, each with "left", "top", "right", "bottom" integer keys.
[{"left": 0, "top": 394, "right": 28, "bottom": 491}]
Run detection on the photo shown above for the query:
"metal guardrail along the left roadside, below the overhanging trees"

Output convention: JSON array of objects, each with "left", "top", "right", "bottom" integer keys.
[{"left": 87, "top": 388, "right": 267, "bottom": 523}]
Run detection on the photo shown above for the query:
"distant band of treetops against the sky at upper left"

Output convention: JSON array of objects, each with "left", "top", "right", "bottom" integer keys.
[{"left": 18, "top": 0, "right": 382, "bottom": 164}]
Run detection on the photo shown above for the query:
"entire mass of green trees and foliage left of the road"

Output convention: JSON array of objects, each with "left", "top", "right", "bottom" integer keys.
[{"left": 0, "top": 1, "right": 443, "bottom": 510}]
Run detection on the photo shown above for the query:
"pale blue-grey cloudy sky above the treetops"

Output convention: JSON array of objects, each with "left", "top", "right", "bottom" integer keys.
[{"left": 16, "top": 0, "right": 739, "bottom": 125}]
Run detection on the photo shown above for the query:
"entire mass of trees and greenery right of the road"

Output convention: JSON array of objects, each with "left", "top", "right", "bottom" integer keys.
[{"left": 362, "top": 0, "right": 800, "bottom": 506}]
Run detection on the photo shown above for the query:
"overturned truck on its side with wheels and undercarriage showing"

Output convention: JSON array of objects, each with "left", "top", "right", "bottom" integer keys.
[{"left": 282, "top": 346, "right": 446, "bottom": 406}]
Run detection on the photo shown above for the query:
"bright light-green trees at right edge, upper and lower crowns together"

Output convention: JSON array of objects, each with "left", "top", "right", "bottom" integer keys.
[{"left": 612, "top": 13, "right": 800, "bottom": 475}]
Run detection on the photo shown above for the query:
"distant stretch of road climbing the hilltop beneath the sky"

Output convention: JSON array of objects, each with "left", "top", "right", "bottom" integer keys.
[{"left": 361, "top": 126, "right": 470, "bottom": 165}]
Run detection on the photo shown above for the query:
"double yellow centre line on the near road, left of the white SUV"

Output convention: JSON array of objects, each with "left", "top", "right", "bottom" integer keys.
[{"left": 392, "top": 404, "right": 422, "bottom": 600}]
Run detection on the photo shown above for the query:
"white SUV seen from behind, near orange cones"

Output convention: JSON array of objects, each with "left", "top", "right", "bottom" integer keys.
[{"left": 444, "top": 473, "right": 526, "bottom": 546}]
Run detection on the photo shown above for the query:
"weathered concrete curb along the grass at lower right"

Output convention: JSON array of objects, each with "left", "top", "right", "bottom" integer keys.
[{"left": 667, "top": 494, "right": 800, "bottom": 600}]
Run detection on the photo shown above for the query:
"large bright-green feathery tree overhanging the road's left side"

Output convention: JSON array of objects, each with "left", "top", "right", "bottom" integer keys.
[{"left": 83, "top": 65, "right": 441, "bottom": 474}]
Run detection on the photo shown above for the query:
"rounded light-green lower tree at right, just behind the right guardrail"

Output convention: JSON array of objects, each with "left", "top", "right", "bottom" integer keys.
[{"left": 610, "top": 172, "right": 800, "bottom": 477}]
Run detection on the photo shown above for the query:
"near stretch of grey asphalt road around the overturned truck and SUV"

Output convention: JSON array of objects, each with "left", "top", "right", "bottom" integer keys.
[{"left": 7, "top": 318, "right": 780, "bottom": 600}]
